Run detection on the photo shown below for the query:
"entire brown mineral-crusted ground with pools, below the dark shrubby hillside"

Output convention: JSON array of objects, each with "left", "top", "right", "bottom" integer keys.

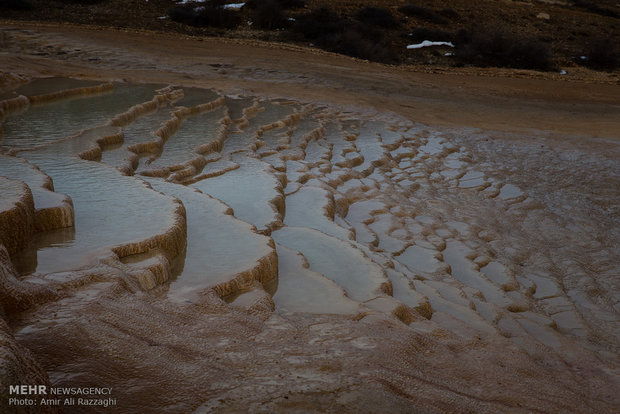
[{"left": 0, "top": 24, "right": 620, "bottom": 413}]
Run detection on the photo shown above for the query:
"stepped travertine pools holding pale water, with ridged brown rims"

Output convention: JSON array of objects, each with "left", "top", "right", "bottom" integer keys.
[{"left": 0, "top": 79, "right": 620, "bottom": 410}]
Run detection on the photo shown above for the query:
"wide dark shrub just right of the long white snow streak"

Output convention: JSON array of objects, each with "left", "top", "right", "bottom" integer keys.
[{"left": 456, "top": 31, "right": 553, "bottom": 70}]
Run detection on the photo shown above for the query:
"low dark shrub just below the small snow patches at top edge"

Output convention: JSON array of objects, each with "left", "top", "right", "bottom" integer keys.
[{"left": 168, "top": 5, "right": 241, "bottom": 29}]
